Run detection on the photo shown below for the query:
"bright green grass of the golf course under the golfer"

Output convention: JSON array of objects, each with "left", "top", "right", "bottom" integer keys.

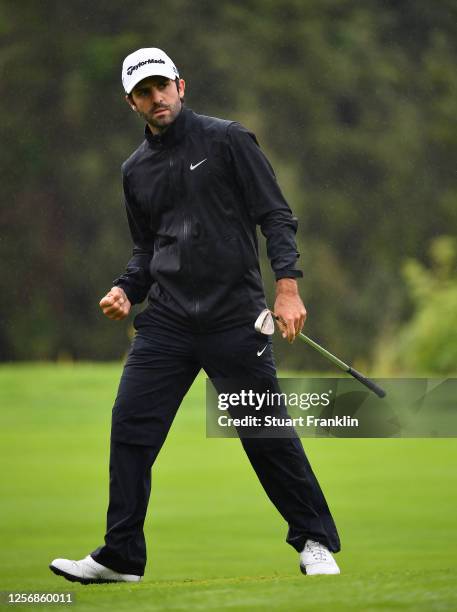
[{"left": 0, "top": 364, "right": 457, "bottom": 612}]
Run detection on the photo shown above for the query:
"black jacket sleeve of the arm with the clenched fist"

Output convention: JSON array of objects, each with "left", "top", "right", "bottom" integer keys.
[{"left": 113, "top": 173, "right": 154, "bottom": 304}]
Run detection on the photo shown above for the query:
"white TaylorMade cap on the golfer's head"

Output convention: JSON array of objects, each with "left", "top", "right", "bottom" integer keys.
[{"left": 122, "top": 48, "right": 179, "bottom": 94}]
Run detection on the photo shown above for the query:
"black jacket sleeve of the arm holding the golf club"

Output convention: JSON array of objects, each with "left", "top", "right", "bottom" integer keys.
[{"left": 228, "top": 123, "right": 303, "bottom": 280}]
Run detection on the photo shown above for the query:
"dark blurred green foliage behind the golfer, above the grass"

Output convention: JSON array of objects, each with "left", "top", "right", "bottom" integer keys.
[{"left": 0, "top": 0, "right": 457, "bottom": 369}]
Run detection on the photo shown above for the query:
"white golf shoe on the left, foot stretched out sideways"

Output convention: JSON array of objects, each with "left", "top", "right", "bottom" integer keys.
[{"left": 49, "top": 555, "right": 142, "bottom": 584}]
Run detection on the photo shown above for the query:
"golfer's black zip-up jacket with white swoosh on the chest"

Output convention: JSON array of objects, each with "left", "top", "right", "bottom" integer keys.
[{"left": 114, "top": 108, "right": 302, "bottom": 331}]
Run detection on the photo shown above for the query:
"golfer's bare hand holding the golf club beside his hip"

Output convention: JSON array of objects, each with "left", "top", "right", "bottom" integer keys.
[{"left": 274, "top": 278, "right": 306, "bottom": 342}]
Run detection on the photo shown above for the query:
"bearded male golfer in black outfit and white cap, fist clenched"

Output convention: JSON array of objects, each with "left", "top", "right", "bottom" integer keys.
[{"left": 50, "top": 48, "right": 340, "bottom": 583}]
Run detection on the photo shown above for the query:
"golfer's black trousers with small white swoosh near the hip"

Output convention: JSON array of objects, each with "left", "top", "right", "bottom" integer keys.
[{"left": 91, "top": 314, "right": 340, "bottom": 575}]
